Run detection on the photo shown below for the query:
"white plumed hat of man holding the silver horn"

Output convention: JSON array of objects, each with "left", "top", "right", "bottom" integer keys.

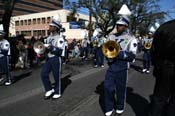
[{"left": 49, "top": 14, "right": 62, "bottom": 28}]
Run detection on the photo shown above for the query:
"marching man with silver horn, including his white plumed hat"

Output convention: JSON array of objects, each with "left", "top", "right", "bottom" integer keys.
[{"left": 41, "top": 15, "right": 65, "bottom": 99}]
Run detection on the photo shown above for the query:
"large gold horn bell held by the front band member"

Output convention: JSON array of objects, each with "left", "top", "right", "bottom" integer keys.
[{"left": 102, "top": 40, "right": 120, "bottom": 58}]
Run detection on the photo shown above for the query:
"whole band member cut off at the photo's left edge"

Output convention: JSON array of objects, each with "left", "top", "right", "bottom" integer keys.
[{"left": 0, "top": 24, "right": 13, "bottom": 85}]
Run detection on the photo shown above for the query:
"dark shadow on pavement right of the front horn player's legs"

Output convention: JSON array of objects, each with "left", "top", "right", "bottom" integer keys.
[{"left": 126, "top": 87, "right": 149, "bottom": 116}]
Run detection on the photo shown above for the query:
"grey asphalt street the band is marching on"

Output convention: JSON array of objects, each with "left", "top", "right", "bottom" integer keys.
[{"left": 0, "top": 54, "right": 154, "bottom": 116}]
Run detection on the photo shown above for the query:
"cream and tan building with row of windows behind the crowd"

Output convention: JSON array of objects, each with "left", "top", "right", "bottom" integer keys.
[{"left": 10, "top": 9, "right": 94, "bottom": 40}]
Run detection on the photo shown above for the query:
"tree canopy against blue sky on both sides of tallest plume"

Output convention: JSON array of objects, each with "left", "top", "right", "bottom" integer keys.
[{"left": 64, "top": 0, "right": 167, "bottom": 36}]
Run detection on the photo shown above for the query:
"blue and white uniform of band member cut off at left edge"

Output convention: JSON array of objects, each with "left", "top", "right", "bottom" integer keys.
[{"left": 0, "top": 39, "right": 12, "bottom": 82}]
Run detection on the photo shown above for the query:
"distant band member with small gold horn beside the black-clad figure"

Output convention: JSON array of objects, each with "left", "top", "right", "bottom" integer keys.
[{"left": 142, "top": 32, "right": 153, "bottom": 73}]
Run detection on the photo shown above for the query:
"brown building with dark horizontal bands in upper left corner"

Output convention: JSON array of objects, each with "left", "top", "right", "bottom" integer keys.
[{"left": 0, "top": 0, "right": 63, "bottom": 22}]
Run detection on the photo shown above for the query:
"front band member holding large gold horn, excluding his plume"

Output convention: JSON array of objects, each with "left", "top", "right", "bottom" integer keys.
[{"left": 104, "top": 16, "right": 137, "bottom": 116}]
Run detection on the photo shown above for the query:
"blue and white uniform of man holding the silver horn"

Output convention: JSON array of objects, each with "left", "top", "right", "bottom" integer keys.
[{"left": 41, "top": 34, "right": 65, "bottom": 94}]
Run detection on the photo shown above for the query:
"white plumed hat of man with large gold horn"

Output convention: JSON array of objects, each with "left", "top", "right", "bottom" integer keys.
[{"left": 116, "top": 4, "right": 131, "bottom": 26}]
